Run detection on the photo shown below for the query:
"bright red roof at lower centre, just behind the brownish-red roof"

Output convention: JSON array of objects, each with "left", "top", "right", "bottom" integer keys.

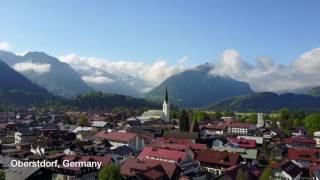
[{"left": 138, "top": 147, "right": 187, "bottom": 162}]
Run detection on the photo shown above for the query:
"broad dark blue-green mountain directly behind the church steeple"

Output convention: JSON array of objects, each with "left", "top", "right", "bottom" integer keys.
[{"left": 145, "top": 64, "right": 252, "bottom": 107}]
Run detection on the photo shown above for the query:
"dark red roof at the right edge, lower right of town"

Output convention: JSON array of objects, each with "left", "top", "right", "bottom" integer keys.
[{"left": 288, "top": 148, "right": 320, "bottom": 162}]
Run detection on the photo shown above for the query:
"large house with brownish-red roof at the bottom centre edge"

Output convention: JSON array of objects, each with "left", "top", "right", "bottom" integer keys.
[{"left": 121, "top": 159, "right": 180, "bottom": 180}]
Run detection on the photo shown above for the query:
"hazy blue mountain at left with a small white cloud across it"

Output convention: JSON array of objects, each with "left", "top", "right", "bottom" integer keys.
[{"left": 0, "top": 51, "right": 92, "bottom": 98}]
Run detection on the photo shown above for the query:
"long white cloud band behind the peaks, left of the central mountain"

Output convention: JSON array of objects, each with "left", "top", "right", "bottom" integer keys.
[{"left": 59, "top": 54, "right": 186, "bottom": 86}]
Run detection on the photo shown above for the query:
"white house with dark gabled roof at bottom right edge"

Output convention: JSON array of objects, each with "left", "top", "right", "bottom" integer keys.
[{"left": 271, "top": 161, "right": 302, "bottom": 180}]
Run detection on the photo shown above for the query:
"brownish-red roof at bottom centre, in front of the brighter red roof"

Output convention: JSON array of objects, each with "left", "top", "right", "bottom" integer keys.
[{"left": 121, "top": 159, "right": 178, "bottom": 178}]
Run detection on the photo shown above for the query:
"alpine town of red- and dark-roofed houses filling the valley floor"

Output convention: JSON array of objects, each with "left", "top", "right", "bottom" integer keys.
[{"left": 0, "top": 90, "right": 320, "bottom": 180}]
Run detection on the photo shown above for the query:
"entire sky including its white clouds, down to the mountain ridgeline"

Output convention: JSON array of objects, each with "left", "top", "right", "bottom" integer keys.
[{"left": 0, "top": 0, "right": 320, "bottom": 91}]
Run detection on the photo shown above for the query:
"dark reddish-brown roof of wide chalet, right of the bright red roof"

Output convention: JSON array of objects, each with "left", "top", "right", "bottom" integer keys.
[{"left": 196, "top": 150, "right": 241, "bottom": 166}]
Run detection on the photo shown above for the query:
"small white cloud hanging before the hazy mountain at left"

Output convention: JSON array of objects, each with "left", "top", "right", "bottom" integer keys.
[{"left": 13, "top": 61, "right": 51, "bottom": 74}]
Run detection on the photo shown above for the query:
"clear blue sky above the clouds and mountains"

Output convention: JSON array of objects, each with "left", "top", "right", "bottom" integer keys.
[{"left": 0, "top": 0, "right": 320, "bottom": 65}]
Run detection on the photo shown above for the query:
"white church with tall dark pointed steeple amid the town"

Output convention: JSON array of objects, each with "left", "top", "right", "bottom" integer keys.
[{"left": 141, "top": 88, "right": 171, "bottom": 121}]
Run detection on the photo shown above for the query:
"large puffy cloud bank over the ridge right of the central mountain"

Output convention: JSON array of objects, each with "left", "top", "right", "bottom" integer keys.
[{"left": 210, "top": 48, "right": 320, "bottom": 92}]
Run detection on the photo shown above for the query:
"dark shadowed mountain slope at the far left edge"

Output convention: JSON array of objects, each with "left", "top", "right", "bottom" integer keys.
[{"left": 0, "top": 60, "right": 54, "bottom": 105}]
